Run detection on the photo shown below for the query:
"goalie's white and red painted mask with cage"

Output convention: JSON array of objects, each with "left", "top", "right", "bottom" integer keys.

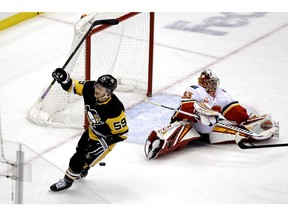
[{"left": 198, "top": 69, "right": 220, "bottom": 92}]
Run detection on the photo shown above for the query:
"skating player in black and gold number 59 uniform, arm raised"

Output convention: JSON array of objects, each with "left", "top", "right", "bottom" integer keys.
[{"left": 50, "top": 68, "right": 128, "bottom": 191}]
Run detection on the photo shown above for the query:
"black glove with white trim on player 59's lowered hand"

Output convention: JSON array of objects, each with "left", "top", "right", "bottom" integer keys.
[{"left": 86, "top": 138, "right": 108, "bottom": 159}]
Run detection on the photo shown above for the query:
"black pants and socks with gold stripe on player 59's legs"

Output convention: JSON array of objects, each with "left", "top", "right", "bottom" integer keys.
[{"left": 65, "top": 130, "right": 116, "bottom": 180}]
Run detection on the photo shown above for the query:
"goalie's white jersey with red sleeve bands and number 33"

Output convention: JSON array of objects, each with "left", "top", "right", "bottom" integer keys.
[{"left": 172, "top": 85, "right": 249, "bottom": 133}]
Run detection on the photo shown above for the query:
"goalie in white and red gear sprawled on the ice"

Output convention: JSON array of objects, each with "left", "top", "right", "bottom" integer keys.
[{"left": 145, "top": 69, "right": 278, "bottom": 159}]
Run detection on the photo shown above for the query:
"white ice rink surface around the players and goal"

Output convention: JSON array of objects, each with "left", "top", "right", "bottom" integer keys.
[{"left": 0, "top": 12, "right": 288, "bottom": 213}]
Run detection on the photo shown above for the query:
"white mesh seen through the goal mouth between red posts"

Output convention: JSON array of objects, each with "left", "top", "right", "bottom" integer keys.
[{"left": 91, "top": 14, "right": 149, "bottom": 92}]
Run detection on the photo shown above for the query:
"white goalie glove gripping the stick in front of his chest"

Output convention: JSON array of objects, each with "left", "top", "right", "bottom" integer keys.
[{"left": 194, "top": 102, "right": 225, "bottom": 127}]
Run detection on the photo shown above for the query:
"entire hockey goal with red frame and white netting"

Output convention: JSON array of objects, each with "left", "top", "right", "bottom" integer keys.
[{"left": 27, "top": 12, "right": 154, "bottom": 128}]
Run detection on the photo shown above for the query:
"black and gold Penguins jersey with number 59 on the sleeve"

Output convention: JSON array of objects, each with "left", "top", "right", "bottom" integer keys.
[{"left": 62, "top": 80, "right": 128, "bottom": 145}]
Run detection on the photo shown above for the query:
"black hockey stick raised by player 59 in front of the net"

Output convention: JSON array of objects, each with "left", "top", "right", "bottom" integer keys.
[{"left": 40, "top": 19, "right": 119, "bottom": 100}]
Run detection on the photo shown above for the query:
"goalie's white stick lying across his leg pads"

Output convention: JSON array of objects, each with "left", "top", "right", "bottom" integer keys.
[{"left": 145, "top": 99, "right": 262, "bottom": 137}]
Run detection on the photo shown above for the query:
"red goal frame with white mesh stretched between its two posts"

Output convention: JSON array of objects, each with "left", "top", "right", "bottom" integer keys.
[{"left": 85, "top": 12, "right": 154, "bottom": 97}]
